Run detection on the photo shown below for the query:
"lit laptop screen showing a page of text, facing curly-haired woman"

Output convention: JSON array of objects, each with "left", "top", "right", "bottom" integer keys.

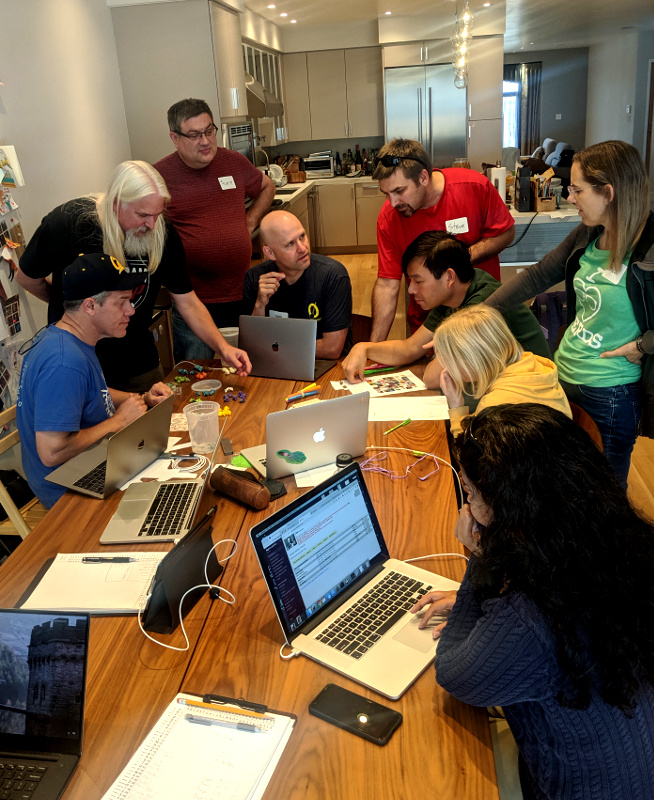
[{"left": 251, "top": 464, "right": 388, "bottom": 635}]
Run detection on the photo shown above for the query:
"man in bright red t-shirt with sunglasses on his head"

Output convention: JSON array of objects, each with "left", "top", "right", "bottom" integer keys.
[{"left": 370, "top": 139, "right": 514, "bottom": 342}]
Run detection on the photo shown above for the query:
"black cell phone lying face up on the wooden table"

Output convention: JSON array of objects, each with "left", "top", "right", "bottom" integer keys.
[{"left": 309, "top": 683, "right": 402, "bottom": 746}]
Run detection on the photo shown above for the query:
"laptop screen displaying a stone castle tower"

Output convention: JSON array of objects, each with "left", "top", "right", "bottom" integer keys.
[{"left": 0, "top": 609, "right": 90, "bottom": 755}]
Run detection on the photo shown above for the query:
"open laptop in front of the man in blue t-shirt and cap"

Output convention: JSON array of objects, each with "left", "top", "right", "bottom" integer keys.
[{"left": 46, "top": 395, "right": 174, "bottom": 500}]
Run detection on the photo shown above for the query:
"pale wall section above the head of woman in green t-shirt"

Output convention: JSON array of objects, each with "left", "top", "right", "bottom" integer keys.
[{"left": 586, "top": 32, "right": 638, "bottom": 145}]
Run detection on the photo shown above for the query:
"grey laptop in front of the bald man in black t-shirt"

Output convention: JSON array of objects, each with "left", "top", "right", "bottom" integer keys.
[{"left": 238, "top": 316, "right": 336, "bottom": 381}]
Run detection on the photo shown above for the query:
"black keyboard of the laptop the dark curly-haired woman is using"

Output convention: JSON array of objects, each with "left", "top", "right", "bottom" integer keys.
[{"left": 316, "top": 572, "right": 432, "bottom": 660}]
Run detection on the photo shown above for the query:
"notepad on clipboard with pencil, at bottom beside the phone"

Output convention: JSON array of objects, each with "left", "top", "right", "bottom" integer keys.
[{"left": 103, "top": 694, "right": 295, "bottom": 800}]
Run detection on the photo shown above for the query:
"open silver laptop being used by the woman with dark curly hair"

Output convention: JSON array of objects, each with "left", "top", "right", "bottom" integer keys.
[{"left": 250, "top": 464, "right": 458, "bottom": 700}]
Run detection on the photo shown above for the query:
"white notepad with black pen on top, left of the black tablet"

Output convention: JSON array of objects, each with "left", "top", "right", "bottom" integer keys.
[{"left": 22, "top": 550, "right": 166, "bottom": 614}]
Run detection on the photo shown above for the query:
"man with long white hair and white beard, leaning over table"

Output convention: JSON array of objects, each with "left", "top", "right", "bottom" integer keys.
[{"left": 16, "top": 161, "right": 251, "bottom": 392}]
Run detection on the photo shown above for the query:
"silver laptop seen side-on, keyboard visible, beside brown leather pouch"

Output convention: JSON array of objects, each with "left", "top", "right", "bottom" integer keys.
[{"left": 100, "top": 422, "right": 225, "bottom": 544}]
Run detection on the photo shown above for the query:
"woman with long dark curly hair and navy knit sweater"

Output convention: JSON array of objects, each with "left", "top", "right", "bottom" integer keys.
[{"left": 414, "top": 403, "right": 654, "bottom": 800}]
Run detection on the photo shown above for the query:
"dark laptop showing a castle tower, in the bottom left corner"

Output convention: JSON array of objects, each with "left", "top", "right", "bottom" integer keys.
[{"left": 0, "top": 608, "right": 90, "bottom": 800}]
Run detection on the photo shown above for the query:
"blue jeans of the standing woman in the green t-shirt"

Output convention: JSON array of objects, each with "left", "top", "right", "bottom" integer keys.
[{"left": 561, "top": 381, "right": 641, "bottom": 489}]
